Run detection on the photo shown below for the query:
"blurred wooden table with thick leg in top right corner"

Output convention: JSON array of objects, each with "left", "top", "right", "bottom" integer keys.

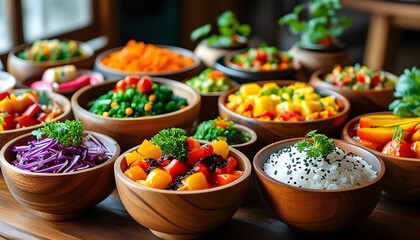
[{"left": 341, "top": 0, "right": 420, "bottom": 72}]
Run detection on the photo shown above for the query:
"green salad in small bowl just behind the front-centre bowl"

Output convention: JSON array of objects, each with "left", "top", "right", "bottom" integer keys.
[{"left": 193, "top": 117, "right": 250, "bottom": 145}]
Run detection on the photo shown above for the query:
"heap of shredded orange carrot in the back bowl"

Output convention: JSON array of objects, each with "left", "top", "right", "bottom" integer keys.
[{"left": 101, "top": 40, "right": 194, "bottom": 73}]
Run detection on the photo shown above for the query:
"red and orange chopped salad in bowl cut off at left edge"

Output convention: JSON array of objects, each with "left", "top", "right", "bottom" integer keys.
[{"left": 0, "top": 91, "right": 63, "bottom": 131}]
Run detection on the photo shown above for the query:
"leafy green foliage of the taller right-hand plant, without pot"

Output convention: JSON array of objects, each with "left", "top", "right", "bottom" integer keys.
[{"left": 278, "top": 0, "right": 352, "bottom": 47}]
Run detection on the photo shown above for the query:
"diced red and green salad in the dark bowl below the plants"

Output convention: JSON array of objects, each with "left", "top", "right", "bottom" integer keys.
[{"left": 232, "top": 46, "right": 293, "bottom": 72}]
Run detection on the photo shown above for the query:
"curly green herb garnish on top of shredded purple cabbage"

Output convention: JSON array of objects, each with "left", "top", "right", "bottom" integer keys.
[{"left": 32, "top": 119, "right": 84, "bottom": 146}]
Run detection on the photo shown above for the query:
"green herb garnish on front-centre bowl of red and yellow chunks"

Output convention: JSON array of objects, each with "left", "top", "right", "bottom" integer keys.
[{"left": 150, "top": 128, "right": 188, "bottom": 161}]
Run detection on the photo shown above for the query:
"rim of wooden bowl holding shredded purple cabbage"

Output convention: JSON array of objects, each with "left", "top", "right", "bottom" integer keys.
[{"left": 0, "top": 130, "right": 121, "bottom": 178}]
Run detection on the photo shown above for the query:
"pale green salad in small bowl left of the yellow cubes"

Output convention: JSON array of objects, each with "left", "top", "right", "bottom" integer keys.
[{"left": 185, "top": 68, "right": 232, "bottom": 93}]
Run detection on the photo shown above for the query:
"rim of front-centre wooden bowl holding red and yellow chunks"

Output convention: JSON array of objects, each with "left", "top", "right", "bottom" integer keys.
[{"left": 114, "top": 145, "right": 252, "bottom": 196}]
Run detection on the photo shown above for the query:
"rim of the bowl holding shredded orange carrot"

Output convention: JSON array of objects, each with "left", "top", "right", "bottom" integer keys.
[{"left": 95, "top": 44, "right": 201, "bottom": 77}]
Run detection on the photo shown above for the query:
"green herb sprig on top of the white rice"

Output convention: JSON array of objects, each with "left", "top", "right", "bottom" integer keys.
[{"left": 296, "top": 130, "right": 335, "bottom": 158}]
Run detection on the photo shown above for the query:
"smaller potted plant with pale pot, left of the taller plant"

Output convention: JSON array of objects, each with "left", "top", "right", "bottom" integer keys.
[{"left": 190, "top": 11, "right": 251, "bottom": 67}]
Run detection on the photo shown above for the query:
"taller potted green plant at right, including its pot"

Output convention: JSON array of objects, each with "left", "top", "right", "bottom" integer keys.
[{"left": 278, "top": 0, "right": 351, "bottom": 78}]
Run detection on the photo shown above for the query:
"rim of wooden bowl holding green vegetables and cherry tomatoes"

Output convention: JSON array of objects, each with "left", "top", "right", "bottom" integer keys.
[{"left": 70, "top": 77, "right": 201, "bottom": 122}]
